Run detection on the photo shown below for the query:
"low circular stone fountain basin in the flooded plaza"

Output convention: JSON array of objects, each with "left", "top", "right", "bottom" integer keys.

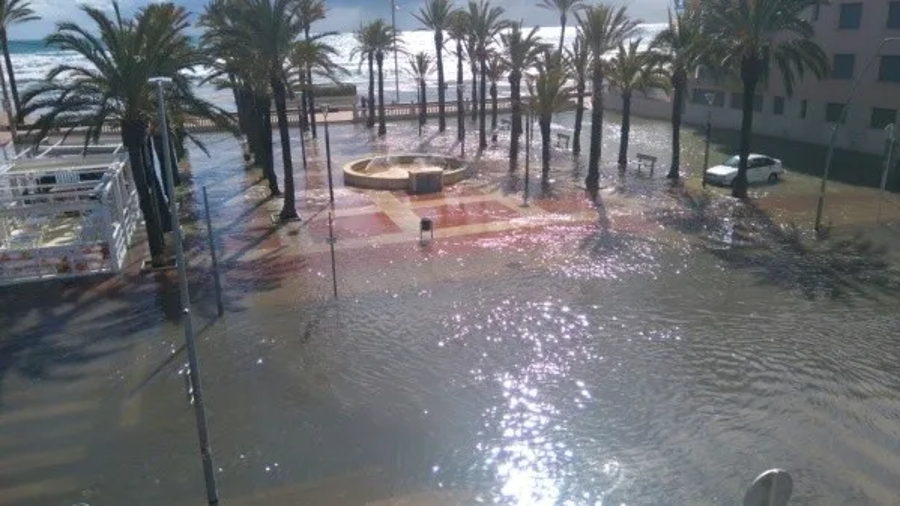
[{"left": 344, "top": 154, "right": 469, "bottom": 192}]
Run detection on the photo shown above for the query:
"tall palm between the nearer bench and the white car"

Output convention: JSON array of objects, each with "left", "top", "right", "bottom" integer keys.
[{"left": 651, "top": 2, "right": 709, "bottom": 179}]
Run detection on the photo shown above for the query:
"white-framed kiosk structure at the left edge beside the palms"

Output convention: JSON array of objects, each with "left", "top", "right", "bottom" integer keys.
[{"left": 0, "top": 143, "right": 141, "bottom": 285}]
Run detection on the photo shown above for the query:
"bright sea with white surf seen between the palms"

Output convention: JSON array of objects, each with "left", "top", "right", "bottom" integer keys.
[{"left": 10, "top": 23, "right": 666, "bottom": 110}]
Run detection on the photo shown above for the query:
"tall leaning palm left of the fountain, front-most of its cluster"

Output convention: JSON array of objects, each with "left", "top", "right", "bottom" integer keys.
[{"left": 227, "top": 0, "right": 303, "bottom": 221}]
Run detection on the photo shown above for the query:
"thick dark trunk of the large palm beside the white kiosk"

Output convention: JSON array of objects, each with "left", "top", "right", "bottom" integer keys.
[{"left": 122, "top": 121, "right": 166, "bottom": 267}]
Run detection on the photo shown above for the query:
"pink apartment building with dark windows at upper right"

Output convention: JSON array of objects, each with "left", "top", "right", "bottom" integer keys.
[{"left": 685, "top": 0, "right": 900, "bottom": 154}]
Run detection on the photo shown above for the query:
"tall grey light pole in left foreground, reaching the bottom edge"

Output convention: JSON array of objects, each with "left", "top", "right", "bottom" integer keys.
[{"left": 150, "top": 77, "right": 219, "bottom": 505}]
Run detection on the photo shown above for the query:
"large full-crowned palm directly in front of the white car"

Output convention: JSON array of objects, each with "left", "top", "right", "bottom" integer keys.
[{"left": 708, "top": 0, "right": 829, "bottom": 198}]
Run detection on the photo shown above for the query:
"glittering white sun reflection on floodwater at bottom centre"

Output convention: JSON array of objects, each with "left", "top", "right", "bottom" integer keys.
[{"left": 441, "top": 298, "right": 622, "bottom": 506}]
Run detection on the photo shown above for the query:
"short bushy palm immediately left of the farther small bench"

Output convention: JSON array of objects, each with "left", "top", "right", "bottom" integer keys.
[{"left": 528, "top": 52, "right": 574, "bottom": 184}]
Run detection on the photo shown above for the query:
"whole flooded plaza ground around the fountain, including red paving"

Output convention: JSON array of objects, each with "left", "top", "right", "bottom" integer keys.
[{"left": 0, "top": 116, "right": 900, "bottom": 506}]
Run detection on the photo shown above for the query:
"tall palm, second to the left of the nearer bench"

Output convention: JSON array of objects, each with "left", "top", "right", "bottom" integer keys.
[{"left": 575, "top": 4, "right": 640, "bottom": 189}]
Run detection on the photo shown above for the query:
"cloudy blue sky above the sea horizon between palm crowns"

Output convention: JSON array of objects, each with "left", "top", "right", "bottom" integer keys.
[{"left": 10, "top": 0, "right": 669, "bottom": 40}]
